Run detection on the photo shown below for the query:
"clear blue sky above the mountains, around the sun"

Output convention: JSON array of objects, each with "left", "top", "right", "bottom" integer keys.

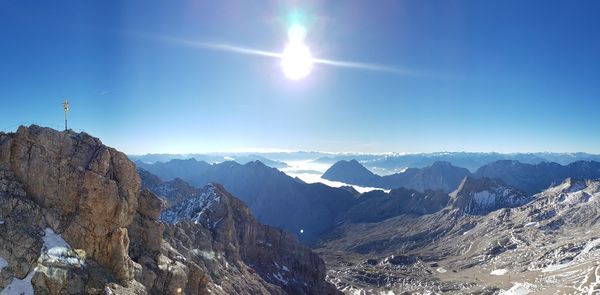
[{"left": 0, "top": 0, "right": 600, "bottom": 153}]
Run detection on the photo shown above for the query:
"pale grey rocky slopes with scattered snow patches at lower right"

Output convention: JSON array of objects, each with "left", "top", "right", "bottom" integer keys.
[{"left": 317, "top": 178, "right": 600, "bottom": 294}]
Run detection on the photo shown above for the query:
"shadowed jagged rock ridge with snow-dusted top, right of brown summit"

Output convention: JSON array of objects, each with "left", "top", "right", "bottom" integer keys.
[{"left": 161, "top": 184, "right": 337, "bottom": 294}]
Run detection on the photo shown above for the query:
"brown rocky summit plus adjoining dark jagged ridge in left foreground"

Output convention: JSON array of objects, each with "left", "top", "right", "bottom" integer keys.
[{"left": 0, "top": 125, "right": 337, "bottom": 294}]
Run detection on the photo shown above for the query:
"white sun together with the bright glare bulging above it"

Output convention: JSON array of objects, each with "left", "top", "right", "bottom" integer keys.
[{"left": 281, "top": 25, "right": 313, "bottom": 80}]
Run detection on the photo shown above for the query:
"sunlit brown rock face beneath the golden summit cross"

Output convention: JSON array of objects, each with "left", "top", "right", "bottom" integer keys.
[{"left": 0, "top": 126, "right": 140, "bottom": 281}]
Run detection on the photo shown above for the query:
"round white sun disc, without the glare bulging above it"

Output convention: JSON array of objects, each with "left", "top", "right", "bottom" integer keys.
[{"left": 281, "top": 40, "right": 313, "bottom": 80}]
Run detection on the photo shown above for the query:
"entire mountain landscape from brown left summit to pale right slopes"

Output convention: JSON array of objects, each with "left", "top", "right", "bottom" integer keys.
[{"left": 0, "top": 125, "right": 600, "bottom": 294}]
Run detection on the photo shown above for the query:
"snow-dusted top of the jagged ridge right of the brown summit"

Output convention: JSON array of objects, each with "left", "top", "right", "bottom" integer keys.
[{"left": 160, "top": 184, "right": 221, "bottom": 225}]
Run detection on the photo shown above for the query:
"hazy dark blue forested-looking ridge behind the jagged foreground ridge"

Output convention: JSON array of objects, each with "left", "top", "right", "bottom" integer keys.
[{"left": 136, "top": 159, "right": 356, "bottom": 241}]
